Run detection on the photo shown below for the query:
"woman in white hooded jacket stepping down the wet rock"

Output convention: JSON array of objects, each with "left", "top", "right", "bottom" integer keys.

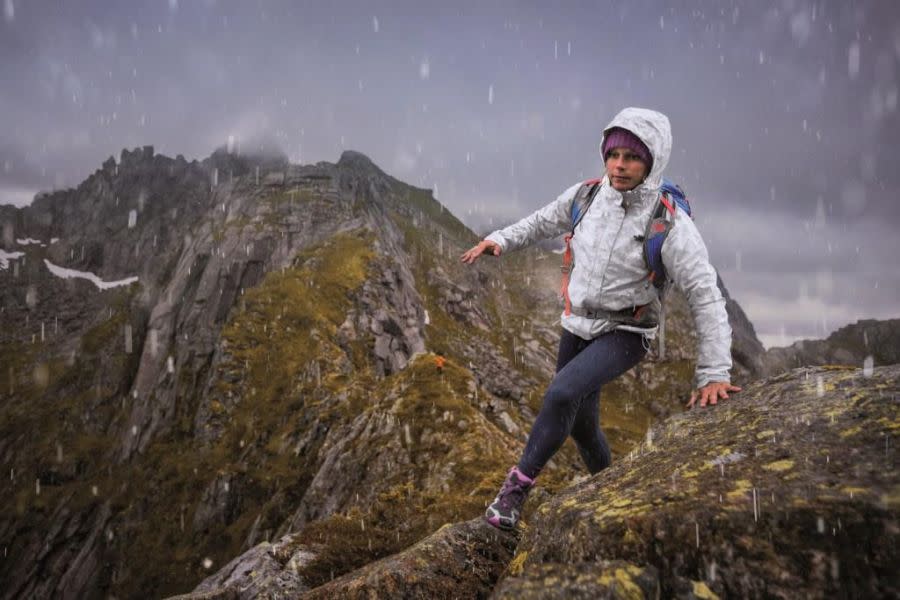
[{"left": 461, "top": 108, "right": 740, "bottom": 529}]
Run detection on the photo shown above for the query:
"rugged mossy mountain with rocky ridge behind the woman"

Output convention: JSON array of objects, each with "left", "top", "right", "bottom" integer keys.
[{"left": 0, "top": 147, "right": 768, "bottom": 598}]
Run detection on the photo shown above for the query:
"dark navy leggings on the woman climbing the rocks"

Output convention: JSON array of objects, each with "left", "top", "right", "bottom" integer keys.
[{"left": 518, "top": 329, "right": 647, "bottom": 478}]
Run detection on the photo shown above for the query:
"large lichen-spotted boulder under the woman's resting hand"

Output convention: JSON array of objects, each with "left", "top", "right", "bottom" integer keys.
[{"left": 496, "top": 365, "right": 900, "bottom": 598}]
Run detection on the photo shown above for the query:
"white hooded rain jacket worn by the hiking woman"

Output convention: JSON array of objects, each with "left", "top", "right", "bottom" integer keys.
[{"left": 485, "top": 108, "right": 731, "bottom": 388}]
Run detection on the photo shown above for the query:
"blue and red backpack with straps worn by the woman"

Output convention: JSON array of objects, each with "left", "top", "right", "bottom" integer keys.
[{"left": 560, "top": 178, "right": 693, "bottom": 359}]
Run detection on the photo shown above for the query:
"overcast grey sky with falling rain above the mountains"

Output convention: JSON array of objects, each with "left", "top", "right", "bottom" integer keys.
[{"left": 0, "top": 0, "right": 900, "bottom": 344}]
